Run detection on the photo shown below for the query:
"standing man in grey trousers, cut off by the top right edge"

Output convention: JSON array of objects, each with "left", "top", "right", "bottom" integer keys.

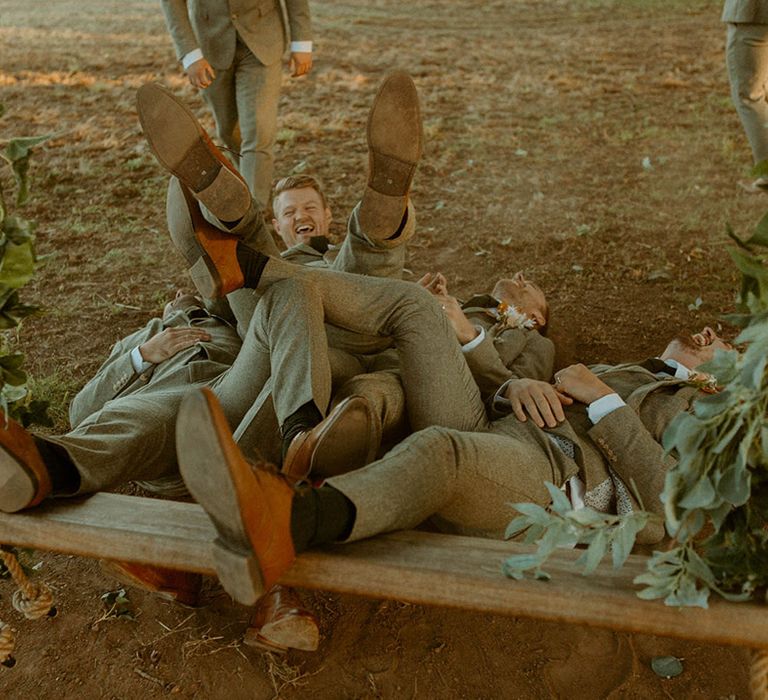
[{"left": 722, "top": 0, "right": 768, "bottom": 189}]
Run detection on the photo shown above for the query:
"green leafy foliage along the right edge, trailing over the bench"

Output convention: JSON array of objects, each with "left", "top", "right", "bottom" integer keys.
[{"left": 504, "top": 214, "right": 768, "bottom": 607}]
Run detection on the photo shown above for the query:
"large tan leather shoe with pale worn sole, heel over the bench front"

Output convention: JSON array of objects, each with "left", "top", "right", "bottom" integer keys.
[{"left": 176, "top": 388, "right": 296, "bottom": 605}]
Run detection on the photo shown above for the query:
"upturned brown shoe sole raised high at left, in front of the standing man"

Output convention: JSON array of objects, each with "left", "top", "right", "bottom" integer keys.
[{"left": 136, "top": 83, "right": 251, "bottom": 221}]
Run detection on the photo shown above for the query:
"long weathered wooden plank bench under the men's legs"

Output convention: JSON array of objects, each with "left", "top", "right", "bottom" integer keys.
[{"left": 0, "top": 493, "right": 768, "bottom": 697}]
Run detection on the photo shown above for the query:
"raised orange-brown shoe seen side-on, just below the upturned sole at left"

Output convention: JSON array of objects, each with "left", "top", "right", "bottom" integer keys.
[{"left": 167, "top": 177, "right": 243, "bottom": 299}]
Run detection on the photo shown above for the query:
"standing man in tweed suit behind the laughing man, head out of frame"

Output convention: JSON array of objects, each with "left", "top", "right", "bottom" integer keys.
[{"left": 162, "top": 0, "right": 312, "bottom": 207}]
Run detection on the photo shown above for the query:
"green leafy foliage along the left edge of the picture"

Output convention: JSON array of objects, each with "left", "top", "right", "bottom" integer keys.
[{"left": 0, "top": 105, "right": 51, "bottom": 426}]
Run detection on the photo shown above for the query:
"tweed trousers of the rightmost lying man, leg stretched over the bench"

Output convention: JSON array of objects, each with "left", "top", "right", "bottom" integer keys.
[{"left": 326, "top": 416, "right": 562, "bottom": 540}]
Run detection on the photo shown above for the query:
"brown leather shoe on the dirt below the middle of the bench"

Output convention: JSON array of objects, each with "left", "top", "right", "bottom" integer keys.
[{"left": 243, "top": 585, "right": 320, "bottom": 652}]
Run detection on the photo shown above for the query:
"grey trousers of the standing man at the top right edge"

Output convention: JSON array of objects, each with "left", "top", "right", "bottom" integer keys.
[{"left": 725, "top": 24, "right": 768, "bottom": 163}]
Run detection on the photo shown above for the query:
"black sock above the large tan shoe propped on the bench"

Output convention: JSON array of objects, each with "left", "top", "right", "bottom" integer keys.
[{"left": 291, "top": 485, "right": 356, "bottom": 552}]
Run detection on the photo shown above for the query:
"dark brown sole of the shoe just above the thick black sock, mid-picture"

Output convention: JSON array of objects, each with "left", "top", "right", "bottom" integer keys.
[{"left": 310, "top": 396, "right": 381, "bottom": 479}]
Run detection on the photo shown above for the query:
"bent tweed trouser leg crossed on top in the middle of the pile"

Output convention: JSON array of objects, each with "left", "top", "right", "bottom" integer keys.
[{"left": 260, "top": 259, "right": 488, "bottom": 430}]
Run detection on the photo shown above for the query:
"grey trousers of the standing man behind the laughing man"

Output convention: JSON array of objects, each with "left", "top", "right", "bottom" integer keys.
[{"left": 203, "top": 37, "right": 282, "bottom": 209}]
